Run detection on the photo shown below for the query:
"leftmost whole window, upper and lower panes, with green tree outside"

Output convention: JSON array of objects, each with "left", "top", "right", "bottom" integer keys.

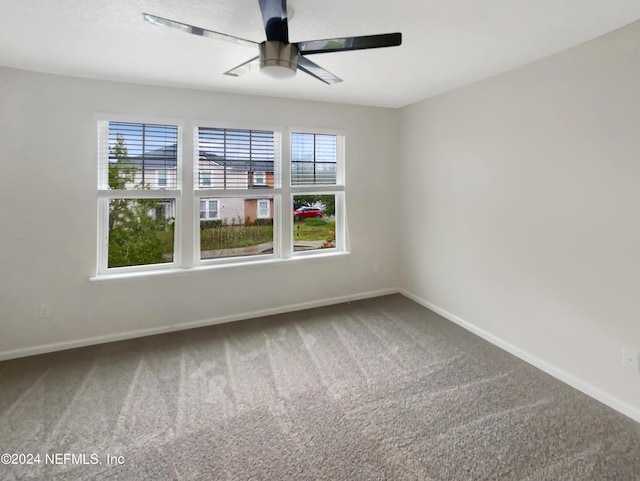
[{"left": 98, "top": 121, "right": 180, "bottom": 272}]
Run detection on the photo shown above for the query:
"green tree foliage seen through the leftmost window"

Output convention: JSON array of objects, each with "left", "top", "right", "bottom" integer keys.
[{"left": 108, "top": 136, "right": 166, "bottom": 267}]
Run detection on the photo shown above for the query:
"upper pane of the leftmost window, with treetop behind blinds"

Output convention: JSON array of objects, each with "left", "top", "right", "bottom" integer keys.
[{"left": 109, "top": 122, "right": 178, "bottom": 190}]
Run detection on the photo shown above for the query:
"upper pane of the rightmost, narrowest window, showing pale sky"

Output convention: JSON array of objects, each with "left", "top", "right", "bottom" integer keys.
[{"left": 291, "top": 132, "right": 338, "bottom": 185}]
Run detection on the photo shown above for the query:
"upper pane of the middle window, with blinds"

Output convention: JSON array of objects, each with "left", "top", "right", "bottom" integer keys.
[{"left": 196, "top": 127, "right": 275, "bottom": 189}]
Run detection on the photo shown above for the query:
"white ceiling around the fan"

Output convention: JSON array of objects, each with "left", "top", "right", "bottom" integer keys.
[{"left": 0, "top": 0, "right": 640, "bottom": 107}]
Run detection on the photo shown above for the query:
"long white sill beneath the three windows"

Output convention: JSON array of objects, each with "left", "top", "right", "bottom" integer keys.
[{"left": 89, "top": 251, "right": 350, "bottom": 284}]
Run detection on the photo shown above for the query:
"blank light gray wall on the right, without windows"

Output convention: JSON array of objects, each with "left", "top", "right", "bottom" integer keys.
[{"left": 400, "top": 19, "right": 640, "bottom": 420}]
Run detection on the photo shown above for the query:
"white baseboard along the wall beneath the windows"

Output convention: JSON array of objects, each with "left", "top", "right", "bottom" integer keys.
[{"left": 0, "top": 288, "right": 399, "bottom": 361}]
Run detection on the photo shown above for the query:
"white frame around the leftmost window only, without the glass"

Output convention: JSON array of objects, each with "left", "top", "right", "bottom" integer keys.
[{"left": 95, "top": 114, "right": 184, "bottom": 275}]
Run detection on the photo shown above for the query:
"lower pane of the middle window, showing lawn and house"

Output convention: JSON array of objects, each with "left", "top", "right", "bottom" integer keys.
[{"left": 200, "top": 197, "right": 273, "bottom": 260}]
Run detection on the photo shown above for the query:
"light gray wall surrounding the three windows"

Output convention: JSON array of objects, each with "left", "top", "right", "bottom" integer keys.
[{"left": 0, "top": 68, "right": 399, "bottom": 357}]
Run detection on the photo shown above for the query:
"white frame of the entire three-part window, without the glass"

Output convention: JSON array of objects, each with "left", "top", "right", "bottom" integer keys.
[{"left": 92, "top": 118, "right": 349, "bottom": 280}]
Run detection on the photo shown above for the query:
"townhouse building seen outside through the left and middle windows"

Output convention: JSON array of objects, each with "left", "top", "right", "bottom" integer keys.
[{"left": 110, "top": 144, "right": 274, "bottom": 224}]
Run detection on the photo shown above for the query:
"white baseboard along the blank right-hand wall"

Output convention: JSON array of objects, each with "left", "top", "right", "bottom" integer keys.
[{"left": 398, "top": 289, "right": 640, "bottom": 422}]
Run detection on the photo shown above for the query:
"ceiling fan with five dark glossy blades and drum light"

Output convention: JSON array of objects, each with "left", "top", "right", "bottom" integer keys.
[{"left": 142, "top": 0, "right": 402, "bottom": 84}]
